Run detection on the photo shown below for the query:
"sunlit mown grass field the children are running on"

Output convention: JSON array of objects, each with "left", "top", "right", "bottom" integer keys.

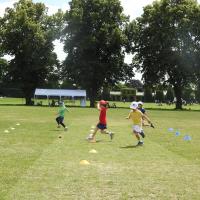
[{"left": 0, "top": 102, "right": 200, "bottom": 200}]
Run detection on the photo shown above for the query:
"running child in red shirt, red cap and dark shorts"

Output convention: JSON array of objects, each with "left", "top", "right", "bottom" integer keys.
[{"left": 87, "top": 100, "right": 114, "bottom": 142}]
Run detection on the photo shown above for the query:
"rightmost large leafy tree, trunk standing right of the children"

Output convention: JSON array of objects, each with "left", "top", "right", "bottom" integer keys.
[{"left": 133, "top": 0, "right": 200, "bottom": 109}]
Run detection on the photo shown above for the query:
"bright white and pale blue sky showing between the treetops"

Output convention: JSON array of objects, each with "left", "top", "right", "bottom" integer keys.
[{"left": 0, "top": 0, "right": 200, "bottom": 79}]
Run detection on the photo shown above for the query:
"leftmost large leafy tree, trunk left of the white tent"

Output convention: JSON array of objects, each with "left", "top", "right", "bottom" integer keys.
[{"left": 0, "top": 0, "right": 63, "bottom": 105}]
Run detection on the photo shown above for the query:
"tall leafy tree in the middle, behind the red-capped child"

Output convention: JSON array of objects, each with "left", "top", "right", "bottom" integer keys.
[{"left": 63, "top": 0, "right": 133, "bottom": 107}]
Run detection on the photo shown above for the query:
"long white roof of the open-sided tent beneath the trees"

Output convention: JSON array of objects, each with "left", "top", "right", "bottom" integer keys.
[{"left": 35, "top": 88, "right": 86, "bottom": 97}]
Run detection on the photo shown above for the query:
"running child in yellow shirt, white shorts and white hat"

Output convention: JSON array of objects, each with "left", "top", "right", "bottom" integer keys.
[{"left": 126, "top": 102, "right": 151, "bottom": 146}]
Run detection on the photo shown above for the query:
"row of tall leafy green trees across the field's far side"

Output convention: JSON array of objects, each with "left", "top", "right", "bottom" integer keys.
[{"left": 0, "top": 0, "right": 200, "bottom": 109}]
